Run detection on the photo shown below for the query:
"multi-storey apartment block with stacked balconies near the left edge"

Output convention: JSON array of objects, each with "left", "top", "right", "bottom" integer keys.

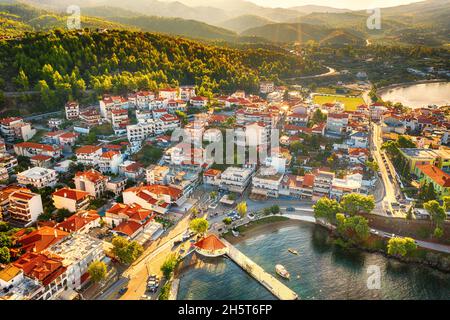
[{"left": 8, "top": 189, "right": 44, "bottom": 226}]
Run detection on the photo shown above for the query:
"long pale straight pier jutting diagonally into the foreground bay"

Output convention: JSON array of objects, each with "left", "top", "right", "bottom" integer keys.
[{"left": 220, "top": 238, "right": 298, "bottom": 300}]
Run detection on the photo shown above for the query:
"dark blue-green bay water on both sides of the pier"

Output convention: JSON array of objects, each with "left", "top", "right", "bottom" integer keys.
[{"left": 178, "top": 223, "right": 450, "bottom": 300}]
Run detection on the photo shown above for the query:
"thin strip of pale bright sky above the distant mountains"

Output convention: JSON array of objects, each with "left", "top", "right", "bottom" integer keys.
[{"left": 237, "top": 0, "right": 421, "bottom": 10}]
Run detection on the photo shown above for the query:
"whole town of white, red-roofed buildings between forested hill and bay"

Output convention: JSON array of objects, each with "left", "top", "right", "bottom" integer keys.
[{"left": 0, "top": 81, "right": 450, "bottom": 300}]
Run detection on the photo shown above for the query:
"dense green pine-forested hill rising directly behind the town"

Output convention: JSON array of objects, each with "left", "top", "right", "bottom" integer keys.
[{"left": 0, "top": 30, "right": 320, "bottom": 110}]
